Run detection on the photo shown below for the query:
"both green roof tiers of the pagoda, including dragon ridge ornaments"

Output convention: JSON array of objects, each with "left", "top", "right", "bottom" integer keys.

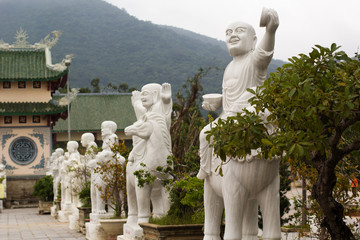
[{"left": 0, "top": 29, "right": 72, "bottom": 120}]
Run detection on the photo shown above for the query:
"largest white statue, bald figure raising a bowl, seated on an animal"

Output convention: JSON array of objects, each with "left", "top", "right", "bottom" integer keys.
[{"left": 197, "top": 8, "right": 281, "bottom": 240}]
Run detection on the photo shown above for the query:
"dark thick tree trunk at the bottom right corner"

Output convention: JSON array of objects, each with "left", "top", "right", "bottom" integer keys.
[{"left": 311, "top": 158, "right": 355, "bottom": 240}]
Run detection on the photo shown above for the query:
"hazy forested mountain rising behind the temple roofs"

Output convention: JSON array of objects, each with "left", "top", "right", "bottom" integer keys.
[{"left": 0, "top": 0, "right": 283, "bottom": 92}]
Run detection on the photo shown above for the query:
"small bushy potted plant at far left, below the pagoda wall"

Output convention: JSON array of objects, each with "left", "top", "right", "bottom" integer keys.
[{"left": 33, "top": 175, "right": 54, "bottom": 214}]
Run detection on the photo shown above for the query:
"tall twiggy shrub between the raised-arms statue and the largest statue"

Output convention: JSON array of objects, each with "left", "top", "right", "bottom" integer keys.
[{"left": 170, "top": 68, "right": 211, "bottom": 177}]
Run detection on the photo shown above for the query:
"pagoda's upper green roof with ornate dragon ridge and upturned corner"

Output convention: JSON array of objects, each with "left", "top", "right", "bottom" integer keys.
[{"left": 0, "top": 29, "right": 72, "bottom": 87}]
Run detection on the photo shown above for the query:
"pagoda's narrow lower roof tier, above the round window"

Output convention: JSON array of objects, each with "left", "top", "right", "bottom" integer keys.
[{"left": 0, "top": 101, "right": 67, "bottom": 116}]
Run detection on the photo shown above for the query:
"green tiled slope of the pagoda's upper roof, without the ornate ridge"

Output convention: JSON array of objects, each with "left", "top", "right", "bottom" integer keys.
[{"left": 0, "top": 49, "right": 68, "bottom": 81}]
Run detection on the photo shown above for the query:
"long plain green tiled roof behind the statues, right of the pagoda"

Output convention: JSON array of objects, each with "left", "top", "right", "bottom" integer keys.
[{"left": 53, "top": 93, "right": 136, "bottom": 132}]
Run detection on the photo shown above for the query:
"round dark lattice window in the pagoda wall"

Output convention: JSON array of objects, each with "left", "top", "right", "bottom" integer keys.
[{"left": 9, "top": 137, "right": 37, "bottom": 165}]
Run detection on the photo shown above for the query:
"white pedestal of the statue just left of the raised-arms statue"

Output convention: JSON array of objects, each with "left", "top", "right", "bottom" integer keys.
[{"left": 85, "top": 213, "right": 112, "bottom": 240}]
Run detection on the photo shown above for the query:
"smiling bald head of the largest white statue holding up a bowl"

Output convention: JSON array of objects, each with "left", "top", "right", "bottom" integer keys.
[{"left": 226, "top": 22, "right": 256, "bottom": 57}]
